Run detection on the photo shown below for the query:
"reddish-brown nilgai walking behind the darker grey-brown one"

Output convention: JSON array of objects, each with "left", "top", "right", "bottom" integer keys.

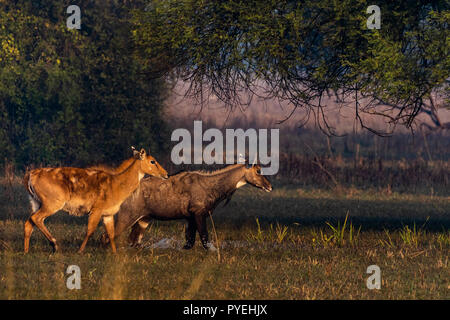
[{"left": 23, "top": 148, "right": 167, "bottom": 253}]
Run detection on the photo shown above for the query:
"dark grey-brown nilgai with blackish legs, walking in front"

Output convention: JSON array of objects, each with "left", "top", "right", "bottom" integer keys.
[{"left": 102, "top": 164, "right": 272, "bottom": 249}]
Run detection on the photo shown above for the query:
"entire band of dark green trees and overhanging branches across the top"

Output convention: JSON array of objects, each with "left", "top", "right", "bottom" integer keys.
[{"left": 0, "top": 0, "right": 450, "bottom": 171}]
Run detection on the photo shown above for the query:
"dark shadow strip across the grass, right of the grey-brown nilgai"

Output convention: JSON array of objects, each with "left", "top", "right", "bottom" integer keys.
[{"left": 215, "top": 197, "right": 450, "bottom": 232}]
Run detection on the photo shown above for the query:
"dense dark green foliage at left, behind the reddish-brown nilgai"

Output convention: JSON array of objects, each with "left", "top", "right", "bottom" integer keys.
[{"left": 0, "top": 0, "right": 169, "bottom": 167}]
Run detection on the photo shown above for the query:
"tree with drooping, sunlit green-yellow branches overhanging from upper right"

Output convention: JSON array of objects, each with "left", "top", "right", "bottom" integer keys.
[{"left": 133, "top": 0, "right": 450, "bottom": 134}]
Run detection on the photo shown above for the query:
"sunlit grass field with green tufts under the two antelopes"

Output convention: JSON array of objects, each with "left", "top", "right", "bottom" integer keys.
[{"left": 0, "top": 178, "right": 450, "bottom": 299}]
